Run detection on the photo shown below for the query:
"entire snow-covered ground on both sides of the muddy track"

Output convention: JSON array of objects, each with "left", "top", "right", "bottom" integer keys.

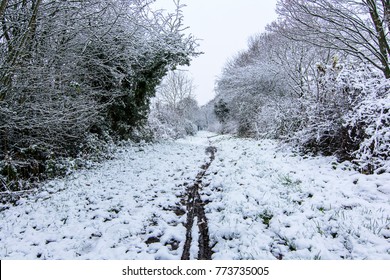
[{"left": 0, "top": 132, "right": 390, "bottom": 260}]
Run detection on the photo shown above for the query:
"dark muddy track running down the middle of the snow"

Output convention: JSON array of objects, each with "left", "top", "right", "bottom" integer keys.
[{"left": 181, "top": 145, "right": 217, "bottom": 260}]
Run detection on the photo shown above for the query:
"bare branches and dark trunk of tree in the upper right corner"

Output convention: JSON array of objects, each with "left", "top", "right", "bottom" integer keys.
[{"left": 269, "top": 0, "right": 390, "bottom": 78}]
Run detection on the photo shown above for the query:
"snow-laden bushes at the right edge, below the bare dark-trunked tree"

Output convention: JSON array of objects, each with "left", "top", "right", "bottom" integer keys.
[{"left": 296, "top": 63, "right": 390, "bottom": 173}]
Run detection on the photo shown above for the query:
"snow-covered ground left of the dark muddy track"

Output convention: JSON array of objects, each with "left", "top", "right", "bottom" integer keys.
[{"left": 0, "top": 134, "right": 213, "bottom": 259}]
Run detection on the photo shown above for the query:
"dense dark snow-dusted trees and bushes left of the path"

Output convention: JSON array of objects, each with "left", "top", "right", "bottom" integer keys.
[{"left": 0, "top": 0, "right": 197, "bottom": 192}]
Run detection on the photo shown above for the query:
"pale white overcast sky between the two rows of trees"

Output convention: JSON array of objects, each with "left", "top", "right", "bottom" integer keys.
[{"left": 152, "top": 0, "right": 276, "bottom": 105}]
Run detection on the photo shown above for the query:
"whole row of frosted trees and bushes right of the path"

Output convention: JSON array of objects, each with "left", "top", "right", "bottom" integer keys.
[{"left": 213, "top": 0, "right": 390, "bottom": 173}]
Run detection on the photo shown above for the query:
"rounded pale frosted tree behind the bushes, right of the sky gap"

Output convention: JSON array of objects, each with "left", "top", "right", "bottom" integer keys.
[{"left": 216, "top": 31, "right": 306, "bottom": 138}]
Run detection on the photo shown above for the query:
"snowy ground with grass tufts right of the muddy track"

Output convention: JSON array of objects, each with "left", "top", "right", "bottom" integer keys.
[{"left": 204, "top": 137, "right": 390, "bottom": 259}]
